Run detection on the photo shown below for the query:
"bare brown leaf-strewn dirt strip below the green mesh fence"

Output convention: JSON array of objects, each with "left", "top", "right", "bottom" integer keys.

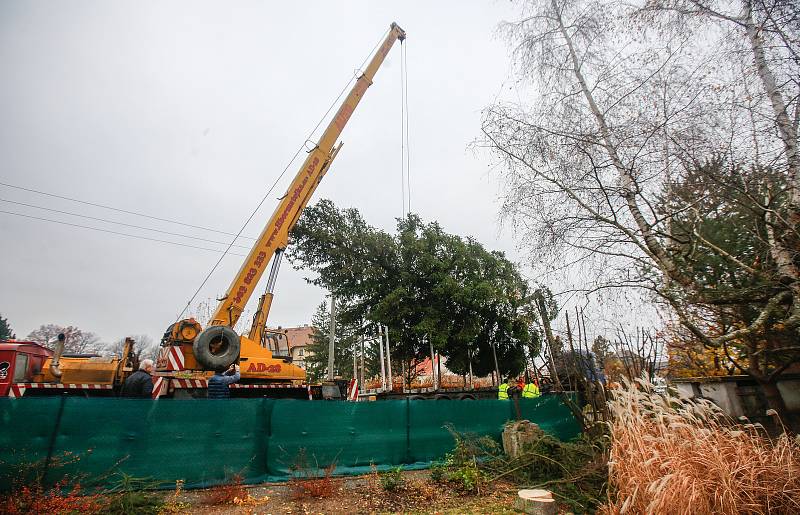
[{"left": 175, "top": 470, "right": 517, "bottom": 515}]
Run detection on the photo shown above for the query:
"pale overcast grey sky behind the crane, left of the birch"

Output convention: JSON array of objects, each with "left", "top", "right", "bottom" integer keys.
[{"left": 0, "top": 0, "right": 519, "bottom": 340}]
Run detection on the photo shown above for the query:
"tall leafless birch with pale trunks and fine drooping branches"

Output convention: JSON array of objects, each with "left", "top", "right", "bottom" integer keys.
[{"left": 482, "top": 0, "right": 800, "bottom": 420}]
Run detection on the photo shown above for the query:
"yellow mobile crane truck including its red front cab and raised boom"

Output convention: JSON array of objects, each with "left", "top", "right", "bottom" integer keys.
[{"left": 0, "top": 23, "right": 406, "bottom": 399}]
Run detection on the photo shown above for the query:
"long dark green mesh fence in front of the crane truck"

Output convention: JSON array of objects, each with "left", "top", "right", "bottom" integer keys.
[{"left": 0, "top": 396, "right": 579, "bottom": 490}]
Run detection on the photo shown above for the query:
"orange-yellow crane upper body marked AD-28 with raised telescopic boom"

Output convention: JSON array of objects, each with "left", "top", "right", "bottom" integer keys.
[{"left": 157, "top": 23, "right": 406, "bottom": 388}]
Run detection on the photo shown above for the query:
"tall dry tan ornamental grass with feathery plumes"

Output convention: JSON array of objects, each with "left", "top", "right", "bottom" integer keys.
[{"left": 603, "top": 381, "right": 800, "bottom": 514}]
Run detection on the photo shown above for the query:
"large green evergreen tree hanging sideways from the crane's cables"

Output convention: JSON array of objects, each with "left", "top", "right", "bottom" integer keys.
[{"left": 289, "top": 200, "right": 540, "bottom": 382}]
